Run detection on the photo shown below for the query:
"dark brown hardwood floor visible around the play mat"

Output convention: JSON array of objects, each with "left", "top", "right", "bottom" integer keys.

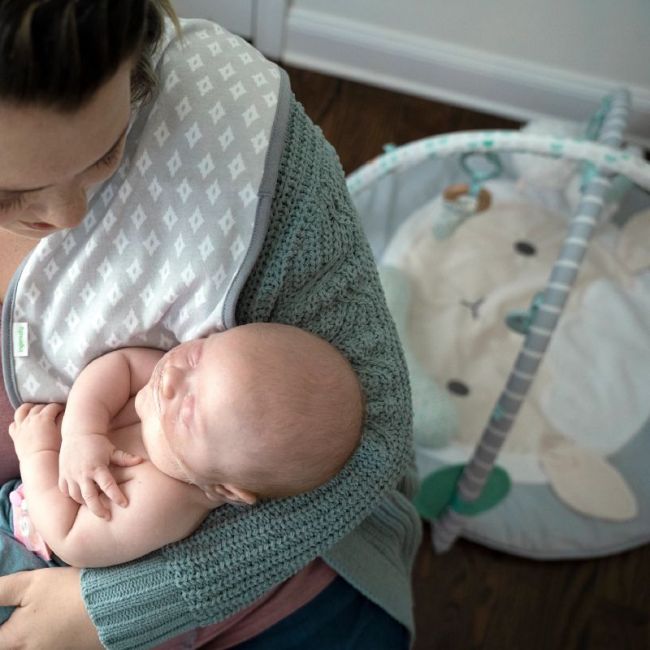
[{"left": 288, "top": 68, "right": 650, "bottom": 650}]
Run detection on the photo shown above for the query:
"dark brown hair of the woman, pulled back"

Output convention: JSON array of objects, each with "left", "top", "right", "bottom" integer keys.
[{"left": 0, "top": 0, "right": 179, "bottom": 111}]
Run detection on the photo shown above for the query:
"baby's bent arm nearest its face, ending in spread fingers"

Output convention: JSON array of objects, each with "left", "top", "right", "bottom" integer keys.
[{"left": 58, "top": 348, "right": 162, "bottom": 517}]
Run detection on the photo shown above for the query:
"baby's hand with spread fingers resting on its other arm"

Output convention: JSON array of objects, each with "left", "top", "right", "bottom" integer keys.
[{"left": 59, "top": 433, "right": 142, "bottom": 519}]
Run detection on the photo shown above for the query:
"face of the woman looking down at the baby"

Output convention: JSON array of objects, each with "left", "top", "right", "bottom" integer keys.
[{"left": 0, "top": 63, "right": 131, "bottom": 239}]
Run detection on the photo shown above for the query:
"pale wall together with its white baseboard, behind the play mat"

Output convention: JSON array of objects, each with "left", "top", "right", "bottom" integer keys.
[{"left": 283, "top": 0, "right": 650, "bottom": 144}]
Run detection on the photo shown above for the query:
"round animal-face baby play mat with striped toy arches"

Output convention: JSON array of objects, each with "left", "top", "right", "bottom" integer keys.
[{"left": 348, "top": 91, "right": 650, "bottom": 559}]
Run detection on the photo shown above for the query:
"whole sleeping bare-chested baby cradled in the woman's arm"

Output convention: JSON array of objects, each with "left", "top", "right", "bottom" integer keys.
[{"left": 10, "top": 323, "right": 363, "bottom": 567}]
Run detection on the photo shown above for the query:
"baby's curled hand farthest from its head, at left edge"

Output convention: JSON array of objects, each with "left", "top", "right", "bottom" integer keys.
[{"left": 9, "top": 403, "right": 63, "bottom": 461}]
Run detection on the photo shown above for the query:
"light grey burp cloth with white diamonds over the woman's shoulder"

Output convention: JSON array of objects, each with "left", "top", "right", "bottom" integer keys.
[{"left": 5, "top": 21, "right": 288, "bottom": 405}]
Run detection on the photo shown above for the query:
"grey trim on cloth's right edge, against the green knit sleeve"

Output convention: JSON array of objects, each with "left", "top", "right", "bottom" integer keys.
[{"left": 223, "top": 68, "right": 292, "bottom": 328}]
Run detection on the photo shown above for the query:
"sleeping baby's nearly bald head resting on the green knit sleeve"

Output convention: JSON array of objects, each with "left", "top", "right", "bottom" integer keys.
[{"left": 139, "top": 323, "right": 363, "bottom": 503}]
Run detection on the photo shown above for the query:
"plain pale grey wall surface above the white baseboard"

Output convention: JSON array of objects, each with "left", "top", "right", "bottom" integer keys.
[{"left": 293, "top": 0, "right": 650, "bottom": 88}]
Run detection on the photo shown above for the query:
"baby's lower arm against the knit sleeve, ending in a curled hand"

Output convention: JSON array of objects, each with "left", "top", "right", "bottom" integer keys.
[{"left": 9, "top": 404, "right": 213, "bottom": 567}]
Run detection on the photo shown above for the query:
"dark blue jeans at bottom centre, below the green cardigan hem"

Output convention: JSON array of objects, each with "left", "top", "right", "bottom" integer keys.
[{"left": 233, "top": 576, "right": 410, "bottom": 650}]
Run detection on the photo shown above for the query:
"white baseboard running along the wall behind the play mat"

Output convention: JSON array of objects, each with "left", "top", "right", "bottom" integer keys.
[{"left": 282, "top": 7, "right": 650, "bottom": 149}]
